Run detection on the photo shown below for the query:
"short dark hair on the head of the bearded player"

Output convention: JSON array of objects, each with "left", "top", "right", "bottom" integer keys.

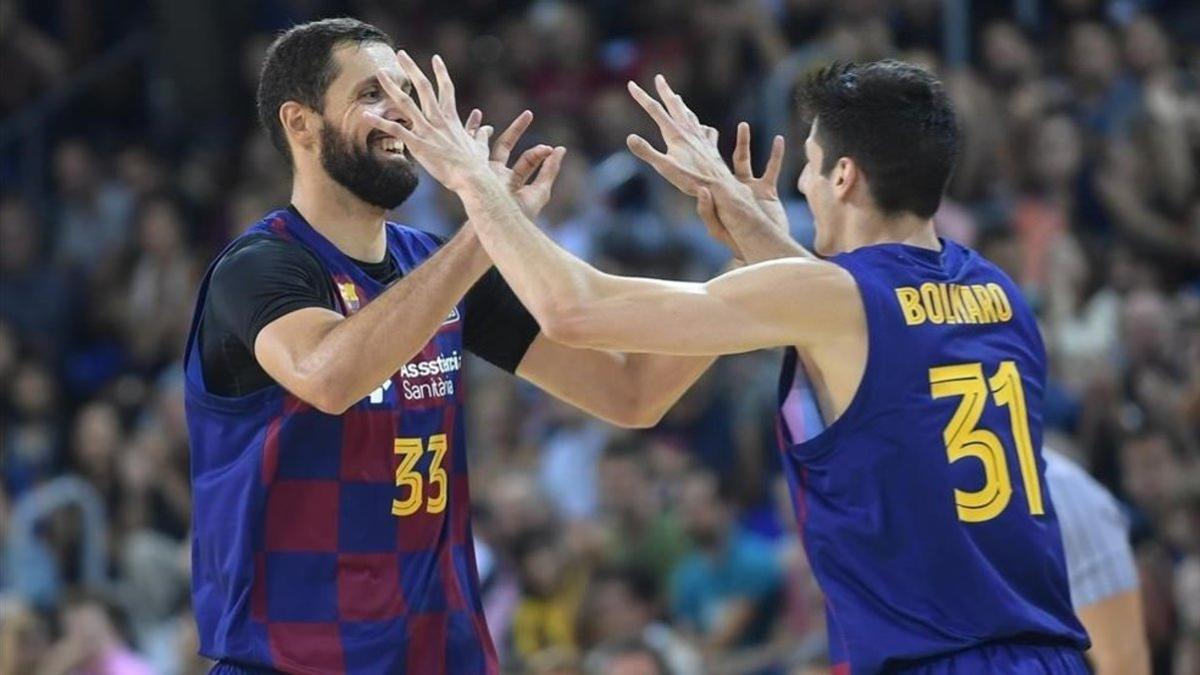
[{"left": 257, "top": 18, "right": 395, "bottom": 160}]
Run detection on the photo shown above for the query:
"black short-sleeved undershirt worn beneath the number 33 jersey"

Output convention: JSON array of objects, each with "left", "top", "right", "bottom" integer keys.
[{"left": 199, "top": 223, "right": 539, "bottom": 396}]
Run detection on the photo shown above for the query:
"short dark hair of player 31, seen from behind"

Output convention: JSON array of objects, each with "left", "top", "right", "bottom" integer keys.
[{"left": 798, "top": 59, "right": 959, "bottom": 217}]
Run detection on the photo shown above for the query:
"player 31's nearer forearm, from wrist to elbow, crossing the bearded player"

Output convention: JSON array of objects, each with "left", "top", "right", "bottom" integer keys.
[{"left": 460, "top": 169, "right": 602, "bottom": 339}]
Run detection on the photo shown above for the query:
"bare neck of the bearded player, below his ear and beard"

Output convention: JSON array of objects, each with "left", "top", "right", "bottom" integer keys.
[{"left": 292, "top": 175, "right": 388, "bottom": 263}]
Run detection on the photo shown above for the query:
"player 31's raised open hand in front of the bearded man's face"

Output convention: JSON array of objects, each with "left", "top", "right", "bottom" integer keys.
[{"left": 364, "top": 49, "right": 492, "bottom": 192}]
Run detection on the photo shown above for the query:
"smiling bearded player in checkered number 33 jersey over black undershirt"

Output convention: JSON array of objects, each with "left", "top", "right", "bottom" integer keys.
[{"left": 185, "top": 19, "right": 713, "bottom": 674}]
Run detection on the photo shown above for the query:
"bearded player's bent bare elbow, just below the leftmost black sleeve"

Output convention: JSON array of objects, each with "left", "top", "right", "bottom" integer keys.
[{"left": 254, "top": 307, "right": 343, "bottom": 412}]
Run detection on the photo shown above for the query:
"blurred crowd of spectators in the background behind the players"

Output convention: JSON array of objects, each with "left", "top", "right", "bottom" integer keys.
[{"left": 0, "top": 0, "right": 1200, "bottom": 675}]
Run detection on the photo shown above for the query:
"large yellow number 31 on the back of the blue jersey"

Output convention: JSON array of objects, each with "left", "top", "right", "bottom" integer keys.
[{"left": 929, "top": 360, "right": 1045, "bottom": 522}]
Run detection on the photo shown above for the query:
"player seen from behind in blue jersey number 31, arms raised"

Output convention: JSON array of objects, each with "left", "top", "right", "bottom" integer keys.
[{"left": 379, "top": 52, "right": 1088, "bottom": 675}]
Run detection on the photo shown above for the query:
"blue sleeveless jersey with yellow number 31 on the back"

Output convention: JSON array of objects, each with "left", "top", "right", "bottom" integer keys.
[{"left": 779, "top": 240, "right": 1087, "bottom": 674}]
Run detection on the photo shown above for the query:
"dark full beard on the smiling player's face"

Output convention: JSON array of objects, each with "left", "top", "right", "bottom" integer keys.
[{"left": 320, "top": 123, "right": 418, "bottom": 210}]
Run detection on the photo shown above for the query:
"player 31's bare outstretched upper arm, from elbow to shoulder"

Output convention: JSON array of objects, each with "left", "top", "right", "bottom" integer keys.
[{"left": 539, "top": 253, "right": 865, "bottom": 356}]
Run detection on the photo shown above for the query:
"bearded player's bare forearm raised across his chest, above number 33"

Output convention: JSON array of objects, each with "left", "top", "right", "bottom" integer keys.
[{"left": 308, "top": 225, "right": 490, "bottom": 412}]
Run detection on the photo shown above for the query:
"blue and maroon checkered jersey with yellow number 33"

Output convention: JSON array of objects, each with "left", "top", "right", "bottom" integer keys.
[{"left": 186, "top": 210, "right": 498, "bottom": 675}]
